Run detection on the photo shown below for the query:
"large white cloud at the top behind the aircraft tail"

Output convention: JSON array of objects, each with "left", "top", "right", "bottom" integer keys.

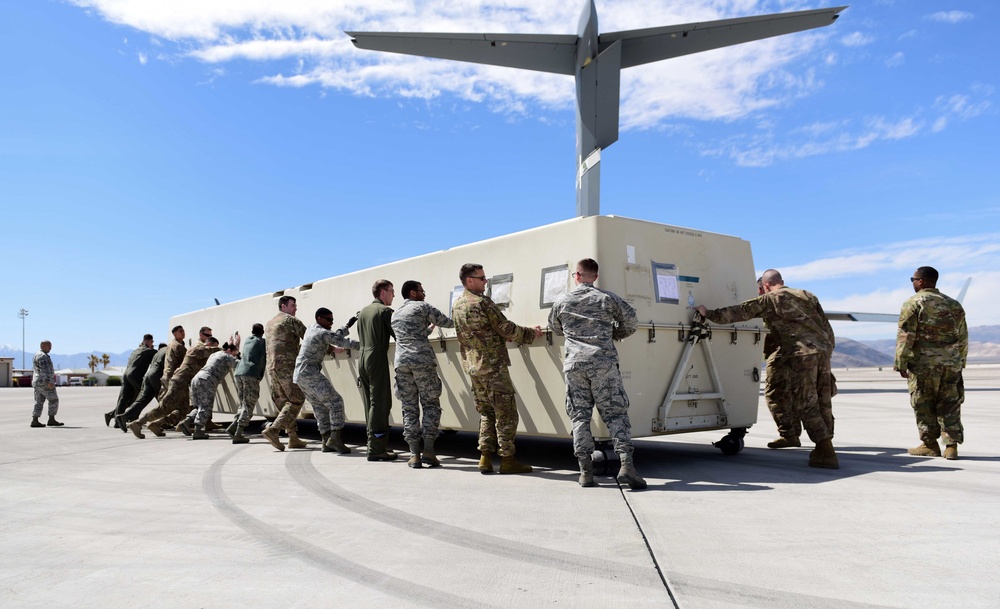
[{"left": 67, "top": 0, "right": 844, "bottom": 129}]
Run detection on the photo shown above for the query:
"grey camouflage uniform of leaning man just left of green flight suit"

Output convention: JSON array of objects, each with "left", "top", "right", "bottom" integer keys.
[{"left": 292, "top": 324, "right": 360, "bottom": 434}]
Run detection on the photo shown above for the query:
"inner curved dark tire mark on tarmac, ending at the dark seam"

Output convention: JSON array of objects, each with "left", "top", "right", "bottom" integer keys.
[{"left": 285, "top": 451, "right": 662, "bottom": 589}]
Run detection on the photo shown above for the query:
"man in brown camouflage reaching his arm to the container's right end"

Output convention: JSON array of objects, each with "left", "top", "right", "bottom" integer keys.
[{"left": 698, "top": 269, "right": 840, "bottom": 469}]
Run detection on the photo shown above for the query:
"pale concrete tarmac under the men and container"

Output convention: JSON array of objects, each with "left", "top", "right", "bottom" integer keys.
[{"left": 0, "top": 366, "right": 1000, "bottom": 609}]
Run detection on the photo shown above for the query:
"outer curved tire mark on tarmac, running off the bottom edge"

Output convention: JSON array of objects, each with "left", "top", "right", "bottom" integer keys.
[{"left": 202, "top": 448, "right": 496, "bottom": 609}]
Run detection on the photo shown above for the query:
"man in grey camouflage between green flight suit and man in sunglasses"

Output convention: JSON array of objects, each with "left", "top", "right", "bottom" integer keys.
[{"left": 392, "top": 281, "right": 455, "bottom": 467}]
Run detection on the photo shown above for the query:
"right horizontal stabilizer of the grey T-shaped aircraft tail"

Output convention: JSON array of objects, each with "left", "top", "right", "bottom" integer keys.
[{"left": 599, "top": 6, "right": 847, "bottom": 68}]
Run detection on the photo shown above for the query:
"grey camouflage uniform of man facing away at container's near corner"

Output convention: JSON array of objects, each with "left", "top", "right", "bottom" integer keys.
[{"left": 549, "top": 282, "right": 639, "bottom": 457}]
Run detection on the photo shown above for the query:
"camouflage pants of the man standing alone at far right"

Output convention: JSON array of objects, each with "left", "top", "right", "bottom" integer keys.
[{"left": 906, "top": 367, "right": 965, "bottom": 445}]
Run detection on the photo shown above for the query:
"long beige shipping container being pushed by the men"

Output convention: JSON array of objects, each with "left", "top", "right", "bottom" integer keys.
[{"left": 170, "top": 216, "right": 764, "bottom": 453}]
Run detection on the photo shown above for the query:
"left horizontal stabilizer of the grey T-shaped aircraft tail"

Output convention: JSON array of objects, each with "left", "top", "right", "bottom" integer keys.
[{"left": 346, "top": 32, "right": 577, "bottom": 75}]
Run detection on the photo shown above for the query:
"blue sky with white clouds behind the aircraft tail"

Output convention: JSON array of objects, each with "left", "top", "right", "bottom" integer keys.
[{"left": 0, "top": 0, "right": 1000, "bottom": 353}]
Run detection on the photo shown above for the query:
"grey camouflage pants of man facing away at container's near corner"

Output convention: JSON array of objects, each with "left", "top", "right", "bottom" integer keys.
[{"left": 565, "top": 365, "right": 632, "bottom": 457}]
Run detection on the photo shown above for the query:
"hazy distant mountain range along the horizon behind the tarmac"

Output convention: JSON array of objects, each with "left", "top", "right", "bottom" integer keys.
[{"left": 0, "top": 326, "right": 1000, "bottom": 370}]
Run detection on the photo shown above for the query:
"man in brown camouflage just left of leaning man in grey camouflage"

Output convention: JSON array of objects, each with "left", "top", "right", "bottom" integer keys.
[{"left": 263, "top": 296, "right": 306, "bottom": 450}]
